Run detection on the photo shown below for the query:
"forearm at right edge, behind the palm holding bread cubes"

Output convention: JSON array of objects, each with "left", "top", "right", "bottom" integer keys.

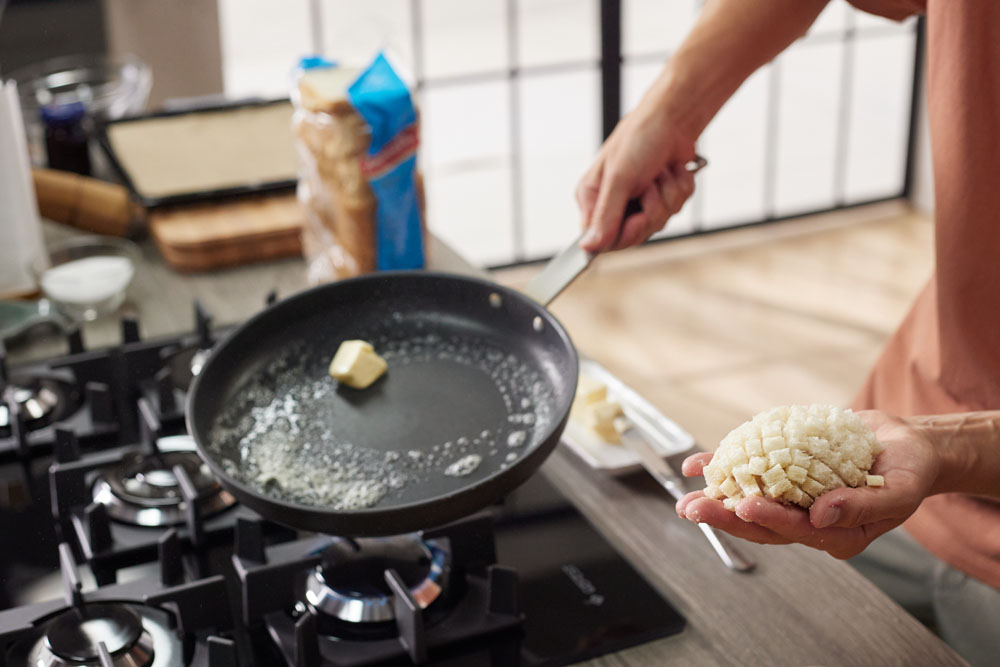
[{"left": 906, "top": 410, "right": 1000, "bottom": 497}]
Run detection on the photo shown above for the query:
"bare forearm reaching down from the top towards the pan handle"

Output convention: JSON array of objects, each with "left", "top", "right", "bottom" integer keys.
[{"left": 640, "top": 0, "right": 828, "bottom": 138}]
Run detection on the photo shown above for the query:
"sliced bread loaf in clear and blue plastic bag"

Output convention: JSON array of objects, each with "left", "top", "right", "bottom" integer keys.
[{"left": 293, "top": 53, "right": 424, "bottom": 282}]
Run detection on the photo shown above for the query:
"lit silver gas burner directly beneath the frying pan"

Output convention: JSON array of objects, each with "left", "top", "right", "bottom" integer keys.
[{"left": 305, "top": 535, "right": 451, "bottom": 624}]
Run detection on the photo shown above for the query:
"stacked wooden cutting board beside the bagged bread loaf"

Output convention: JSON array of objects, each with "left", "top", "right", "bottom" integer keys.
[{"left": 149, "top": 194, "right": 305, "bottom": 272}]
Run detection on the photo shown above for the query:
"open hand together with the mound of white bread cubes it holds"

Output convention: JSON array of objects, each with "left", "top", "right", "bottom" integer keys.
[{"left": 677, "top": 406, "right": 940, "bottom": 558}]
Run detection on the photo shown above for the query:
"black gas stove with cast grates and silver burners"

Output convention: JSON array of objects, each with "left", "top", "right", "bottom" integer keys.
[{"left": 0, "top": 304, "right": 684, "bottom": 667}]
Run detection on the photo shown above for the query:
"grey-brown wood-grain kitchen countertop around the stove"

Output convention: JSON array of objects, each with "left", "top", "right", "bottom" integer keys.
[{"left": 10, "top": 226, "right": 965, "bottom": 667}]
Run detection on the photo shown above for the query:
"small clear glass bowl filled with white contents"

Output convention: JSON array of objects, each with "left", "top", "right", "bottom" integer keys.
[{"left": 32, "top": 236, "right": 142, "bottom": 321}]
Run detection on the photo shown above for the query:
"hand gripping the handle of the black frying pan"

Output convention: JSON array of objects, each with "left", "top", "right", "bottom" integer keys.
[{"left": 576, "top": 104, "right": 696, "bottom": 252}]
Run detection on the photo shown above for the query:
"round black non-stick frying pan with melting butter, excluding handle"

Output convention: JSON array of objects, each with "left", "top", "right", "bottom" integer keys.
[{"left": 190, "top": 274, "right": 576, "bottom": 534}]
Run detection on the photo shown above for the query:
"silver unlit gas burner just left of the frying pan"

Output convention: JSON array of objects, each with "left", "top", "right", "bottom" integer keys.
[{"left": 92, "top": 436, "right": 236, "bottom": 527}]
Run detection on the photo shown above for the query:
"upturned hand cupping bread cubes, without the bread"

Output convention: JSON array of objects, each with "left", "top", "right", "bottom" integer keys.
[{"left": 677, "top": 410, "right": 940, "bottom": 558}]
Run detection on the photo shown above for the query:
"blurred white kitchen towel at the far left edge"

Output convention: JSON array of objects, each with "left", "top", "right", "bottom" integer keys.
[{"left": 0, "top": 81, "right": 46, "bottom": 297}]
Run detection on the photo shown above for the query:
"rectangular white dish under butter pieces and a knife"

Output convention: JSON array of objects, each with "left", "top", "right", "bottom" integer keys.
[{"left": 562, "top": 359, "right": 694, "bottom": 475}]
